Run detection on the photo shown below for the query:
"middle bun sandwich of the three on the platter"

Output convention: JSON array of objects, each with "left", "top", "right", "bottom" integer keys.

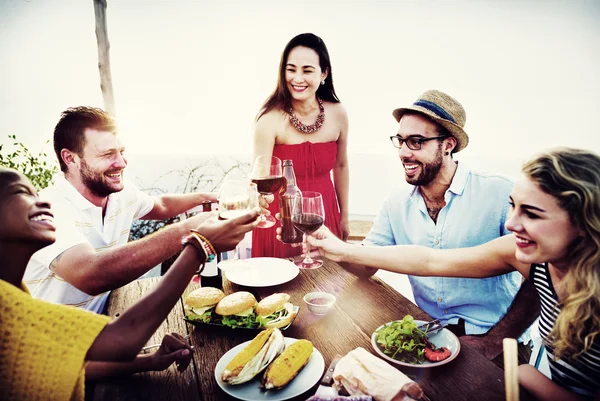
[{"left": 215, "top": 291, "right": 259, "bottom": 328}]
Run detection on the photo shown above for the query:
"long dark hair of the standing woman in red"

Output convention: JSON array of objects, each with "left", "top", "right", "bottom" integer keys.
[{"left": 256, "top": 33, "right": 340, "bottom": 120}]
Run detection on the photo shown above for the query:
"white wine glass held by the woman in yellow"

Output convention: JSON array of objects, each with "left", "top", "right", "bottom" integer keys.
[{"left": 219, "top": 178, "right": 258, "bottom": 260}]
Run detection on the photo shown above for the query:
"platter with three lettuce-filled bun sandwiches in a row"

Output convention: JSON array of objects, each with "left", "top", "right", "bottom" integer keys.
[{"left": 184, "top": 287, "right": 300, "bottom": 330}]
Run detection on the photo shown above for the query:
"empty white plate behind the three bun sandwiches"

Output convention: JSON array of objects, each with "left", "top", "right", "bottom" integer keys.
[{"left": 219, "top": 258, "right": 300, "bottom": 287}]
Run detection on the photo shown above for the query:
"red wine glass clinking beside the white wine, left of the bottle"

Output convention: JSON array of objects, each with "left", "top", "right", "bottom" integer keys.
[{"left": 250, "top": 155, "right": 285, "bottom": 228}]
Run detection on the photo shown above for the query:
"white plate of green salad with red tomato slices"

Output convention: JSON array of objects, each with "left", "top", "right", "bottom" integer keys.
[{"left": 371, "top": 315, "right": 460, "bottom": 368}]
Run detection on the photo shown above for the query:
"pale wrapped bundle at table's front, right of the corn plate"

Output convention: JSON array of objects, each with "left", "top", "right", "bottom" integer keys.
[{"left": 333, "top": 348, "right": 423, "bottom": 401}]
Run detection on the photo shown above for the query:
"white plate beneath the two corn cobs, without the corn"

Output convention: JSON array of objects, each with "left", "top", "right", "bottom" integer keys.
[{"left": 215, "top": 337, "right": 325, "bottom": 401}]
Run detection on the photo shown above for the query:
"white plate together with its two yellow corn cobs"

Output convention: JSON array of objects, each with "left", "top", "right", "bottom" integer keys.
[{"left": 215, "top": 329, "right": 325, "bottom": 401}]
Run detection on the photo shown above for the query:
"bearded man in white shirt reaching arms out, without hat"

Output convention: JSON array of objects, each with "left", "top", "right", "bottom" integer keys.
[{"left": 24, "top": 107, "right": 216, "bottom": 313}]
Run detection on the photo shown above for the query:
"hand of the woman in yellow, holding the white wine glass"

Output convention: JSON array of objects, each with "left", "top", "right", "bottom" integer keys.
[{"left": 196, "top": 208, "right": 260, "bottom": 252}]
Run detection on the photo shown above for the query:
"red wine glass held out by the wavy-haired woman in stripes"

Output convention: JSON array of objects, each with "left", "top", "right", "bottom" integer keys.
[{"left": 292, "top": 191, "right": 325, "bottom": 269}]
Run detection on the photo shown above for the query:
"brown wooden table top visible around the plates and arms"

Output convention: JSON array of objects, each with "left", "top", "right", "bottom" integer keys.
[{"left": 88, "top": 260, "right": 529, "bottom": 401}]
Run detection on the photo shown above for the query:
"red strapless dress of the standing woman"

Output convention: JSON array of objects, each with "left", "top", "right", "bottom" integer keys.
[{"left": 252, "top": 142, "right": 342, "bottom": 258}]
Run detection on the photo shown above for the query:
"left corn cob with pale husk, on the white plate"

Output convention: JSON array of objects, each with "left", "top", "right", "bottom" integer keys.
[{"left": 221, "top": 329, "right": 285, "bottom": 384}]
